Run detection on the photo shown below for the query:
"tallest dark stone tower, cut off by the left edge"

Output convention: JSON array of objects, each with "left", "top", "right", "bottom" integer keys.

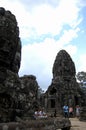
[{"left": 0, "top": 7, "right": 21, "bottom": 121}]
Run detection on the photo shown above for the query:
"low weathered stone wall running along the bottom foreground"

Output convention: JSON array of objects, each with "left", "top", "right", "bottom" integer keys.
[{"left": 0, "top": 118, "right": 71, "bottom": 130}]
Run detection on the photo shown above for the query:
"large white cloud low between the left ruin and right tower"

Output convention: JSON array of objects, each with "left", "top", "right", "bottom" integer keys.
[{"left": 19, "top": 34, "right": 77, "bottom": 90}]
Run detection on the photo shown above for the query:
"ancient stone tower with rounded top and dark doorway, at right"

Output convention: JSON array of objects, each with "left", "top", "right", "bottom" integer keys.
[{"left": 45, "top": 50, "right": 81, "bottom": 113}]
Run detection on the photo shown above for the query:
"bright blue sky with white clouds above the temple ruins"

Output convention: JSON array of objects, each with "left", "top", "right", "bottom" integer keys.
[{"left": 0, "top": 0, "right": 86, "bottom": 91}]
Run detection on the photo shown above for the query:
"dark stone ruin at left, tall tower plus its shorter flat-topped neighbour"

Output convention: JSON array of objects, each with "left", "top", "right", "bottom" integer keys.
[{"left": 0, "top": 7, "right": 38, "bottom": 122}]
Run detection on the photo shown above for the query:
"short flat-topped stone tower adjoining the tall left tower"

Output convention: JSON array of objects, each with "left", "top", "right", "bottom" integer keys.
[{"left": 20, "top": 75, "right": 39, "bottom": 116}]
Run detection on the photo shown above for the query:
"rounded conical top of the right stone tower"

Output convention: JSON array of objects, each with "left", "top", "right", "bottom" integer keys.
[{"left": 53, "top": 50, "right": 76, "bottom": 80}]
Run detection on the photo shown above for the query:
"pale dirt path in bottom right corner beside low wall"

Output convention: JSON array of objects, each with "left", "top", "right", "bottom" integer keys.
[{"left": 69, "top": 118, "right": 86, "bottom": 130}]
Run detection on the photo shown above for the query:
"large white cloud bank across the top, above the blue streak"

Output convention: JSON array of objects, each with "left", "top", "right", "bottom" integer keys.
[{"left": 1, "top": 0, "right": 79, "bottom": 38}]
